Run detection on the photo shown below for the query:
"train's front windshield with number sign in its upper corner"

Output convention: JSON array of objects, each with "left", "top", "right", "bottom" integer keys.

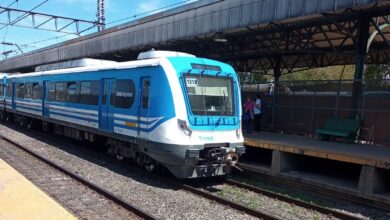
[{"left": 184, "top": 74, "right": 235, "bottom": 116}]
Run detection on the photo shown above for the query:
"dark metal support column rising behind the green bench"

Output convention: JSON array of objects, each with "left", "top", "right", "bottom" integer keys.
[{"left": 351, "top": 17, "right": 370, "bottom": 117}]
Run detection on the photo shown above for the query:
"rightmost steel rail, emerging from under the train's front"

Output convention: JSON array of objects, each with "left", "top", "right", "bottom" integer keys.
[{"left": 225, "top": 178, "right": 363, "bottom": 220}]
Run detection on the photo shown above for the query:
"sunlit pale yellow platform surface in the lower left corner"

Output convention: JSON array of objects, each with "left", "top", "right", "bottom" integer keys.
[{"left": 0, "top": 159, "right": 77, "bottom": 220}]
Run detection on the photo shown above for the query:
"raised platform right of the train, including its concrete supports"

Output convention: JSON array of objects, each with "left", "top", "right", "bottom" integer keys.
[{"left": 238, "top": 132, "right": 390, "bottom": 210}]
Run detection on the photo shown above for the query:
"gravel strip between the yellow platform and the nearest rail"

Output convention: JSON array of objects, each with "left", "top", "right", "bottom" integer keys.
[{"left": 0, "top": 140, "right": 141, "bottom": 220}]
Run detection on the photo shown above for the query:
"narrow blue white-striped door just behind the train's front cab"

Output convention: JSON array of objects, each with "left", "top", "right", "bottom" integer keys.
[{"left": 137, "top": 77, "right": 150, "bottom": 139}]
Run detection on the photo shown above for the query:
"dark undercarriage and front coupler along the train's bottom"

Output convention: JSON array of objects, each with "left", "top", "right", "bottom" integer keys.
[{"left": 0, "top": 111, "right": 245, "bottom": 178}]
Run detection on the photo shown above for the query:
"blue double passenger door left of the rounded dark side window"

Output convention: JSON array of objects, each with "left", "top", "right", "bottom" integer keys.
[{"left": 99, "top": 79, "right": 115, "bottom": 132}]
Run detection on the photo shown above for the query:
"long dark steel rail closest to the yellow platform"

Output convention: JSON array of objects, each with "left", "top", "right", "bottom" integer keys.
[{"left": 0, "top": 135, "right": 158, "bottom": 220}]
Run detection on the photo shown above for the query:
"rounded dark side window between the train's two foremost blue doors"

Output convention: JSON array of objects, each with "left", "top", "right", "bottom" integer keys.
[{"left": 114, "top": 79, "right": 135, "bottom": 108}]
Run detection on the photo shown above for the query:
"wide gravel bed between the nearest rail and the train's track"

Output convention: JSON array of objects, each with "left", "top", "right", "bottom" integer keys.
[{"left": 0, "top": 125, "right": 255, "bottom": 220}]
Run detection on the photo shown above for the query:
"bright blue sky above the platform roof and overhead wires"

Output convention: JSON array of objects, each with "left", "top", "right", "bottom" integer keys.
[{"left": 0, "top": 0, "right": 197, "bottom": 60}]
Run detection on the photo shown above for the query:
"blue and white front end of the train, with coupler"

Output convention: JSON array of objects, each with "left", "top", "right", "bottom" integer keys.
[{"left": 158, "top": 57, "right": 245, "bottom": 178}]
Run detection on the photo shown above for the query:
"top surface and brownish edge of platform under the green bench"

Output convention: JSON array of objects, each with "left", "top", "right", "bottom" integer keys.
[{"left": 244, "top": 132, "right": 390, "bottom": 169}]
